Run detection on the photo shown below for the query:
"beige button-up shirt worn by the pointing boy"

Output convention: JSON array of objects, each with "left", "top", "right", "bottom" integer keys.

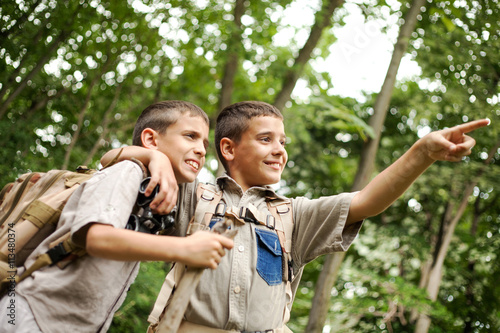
[{"left": 174, "top": 176, "right": 362, "bottom": 331}]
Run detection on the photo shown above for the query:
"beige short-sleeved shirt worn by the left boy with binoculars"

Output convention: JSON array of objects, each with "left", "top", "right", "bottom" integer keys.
[{"left": 16, "top": 161, "right": 142, "bottom": 333}]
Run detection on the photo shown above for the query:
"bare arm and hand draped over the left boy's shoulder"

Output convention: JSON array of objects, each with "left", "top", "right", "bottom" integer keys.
[{"left": 101, "top": 146, "right": 179, "bottom": 214}]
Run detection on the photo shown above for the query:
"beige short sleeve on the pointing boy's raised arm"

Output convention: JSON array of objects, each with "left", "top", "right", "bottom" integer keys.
[{"left": 292, "top": 192, "right": 363, "bottom": 268}]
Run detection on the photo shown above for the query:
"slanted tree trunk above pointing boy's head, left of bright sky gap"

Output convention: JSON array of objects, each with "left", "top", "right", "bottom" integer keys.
[{"left": 273, "top": 0, "right": 344, "bottom": 111}]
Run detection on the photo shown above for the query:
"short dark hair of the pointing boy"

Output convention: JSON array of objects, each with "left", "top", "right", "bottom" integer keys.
[{"left": 215, "top": 101, "right": 283, "bottom": 171}]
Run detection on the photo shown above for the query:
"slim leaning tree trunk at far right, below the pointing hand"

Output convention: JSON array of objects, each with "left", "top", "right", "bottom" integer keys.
[{"left": 415, "top": 141, "right": 500, "bottom": 333}]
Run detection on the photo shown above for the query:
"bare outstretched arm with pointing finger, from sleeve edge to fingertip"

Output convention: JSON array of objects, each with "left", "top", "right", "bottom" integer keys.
[{"left": 347, "top": 119, "right": 489, "bottom": 223}]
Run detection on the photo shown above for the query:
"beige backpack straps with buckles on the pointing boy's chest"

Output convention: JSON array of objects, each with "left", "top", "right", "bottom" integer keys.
[{"left": 148, "top": 183, "right": 294, "bottom": 333}]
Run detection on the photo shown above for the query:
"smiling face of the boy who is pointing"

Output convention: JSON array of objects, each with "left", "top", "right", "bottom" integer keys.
[{"left": 221, "top": 116, "right": 288, "bottom": 191}]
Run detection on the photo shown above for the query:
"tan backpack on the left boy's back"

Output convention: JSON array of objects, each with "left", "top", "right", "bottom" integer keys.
[{"left": 0, "top": 151, "right": 147, "bottom": 295}]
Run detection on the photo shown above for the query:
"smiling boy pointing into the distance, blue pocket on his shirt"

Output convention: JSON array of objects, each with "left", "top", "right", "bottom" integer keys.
[{"left": 103, "top": 102, "right": 489, "bottom": 332}]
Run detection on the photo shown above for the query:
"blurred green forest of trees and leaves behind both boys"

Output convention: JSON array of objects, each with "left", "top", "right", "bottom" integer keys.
[{"left": 0, "top": 0, "right": 500, "bottom": 332}]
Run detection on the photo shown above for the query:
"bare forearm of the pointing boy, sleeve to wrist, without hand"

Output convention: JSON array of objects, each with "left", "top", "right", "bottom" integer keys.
[{"left": 348, "top": 140, "right": 435, "bottom": 222}]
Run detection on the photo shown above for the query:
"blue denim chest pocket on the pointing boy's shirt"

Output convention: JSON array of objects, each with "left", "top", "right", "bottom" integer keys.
[{"left": 255, "top": 229, "right": 283, "bottom": 286}]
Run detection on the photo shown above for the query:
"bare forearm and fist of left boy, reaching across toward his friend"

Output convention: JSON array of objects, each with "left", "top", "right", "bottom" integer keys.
[{"left": 85, "top": 223, "right": 233, "bottom": 269}]
